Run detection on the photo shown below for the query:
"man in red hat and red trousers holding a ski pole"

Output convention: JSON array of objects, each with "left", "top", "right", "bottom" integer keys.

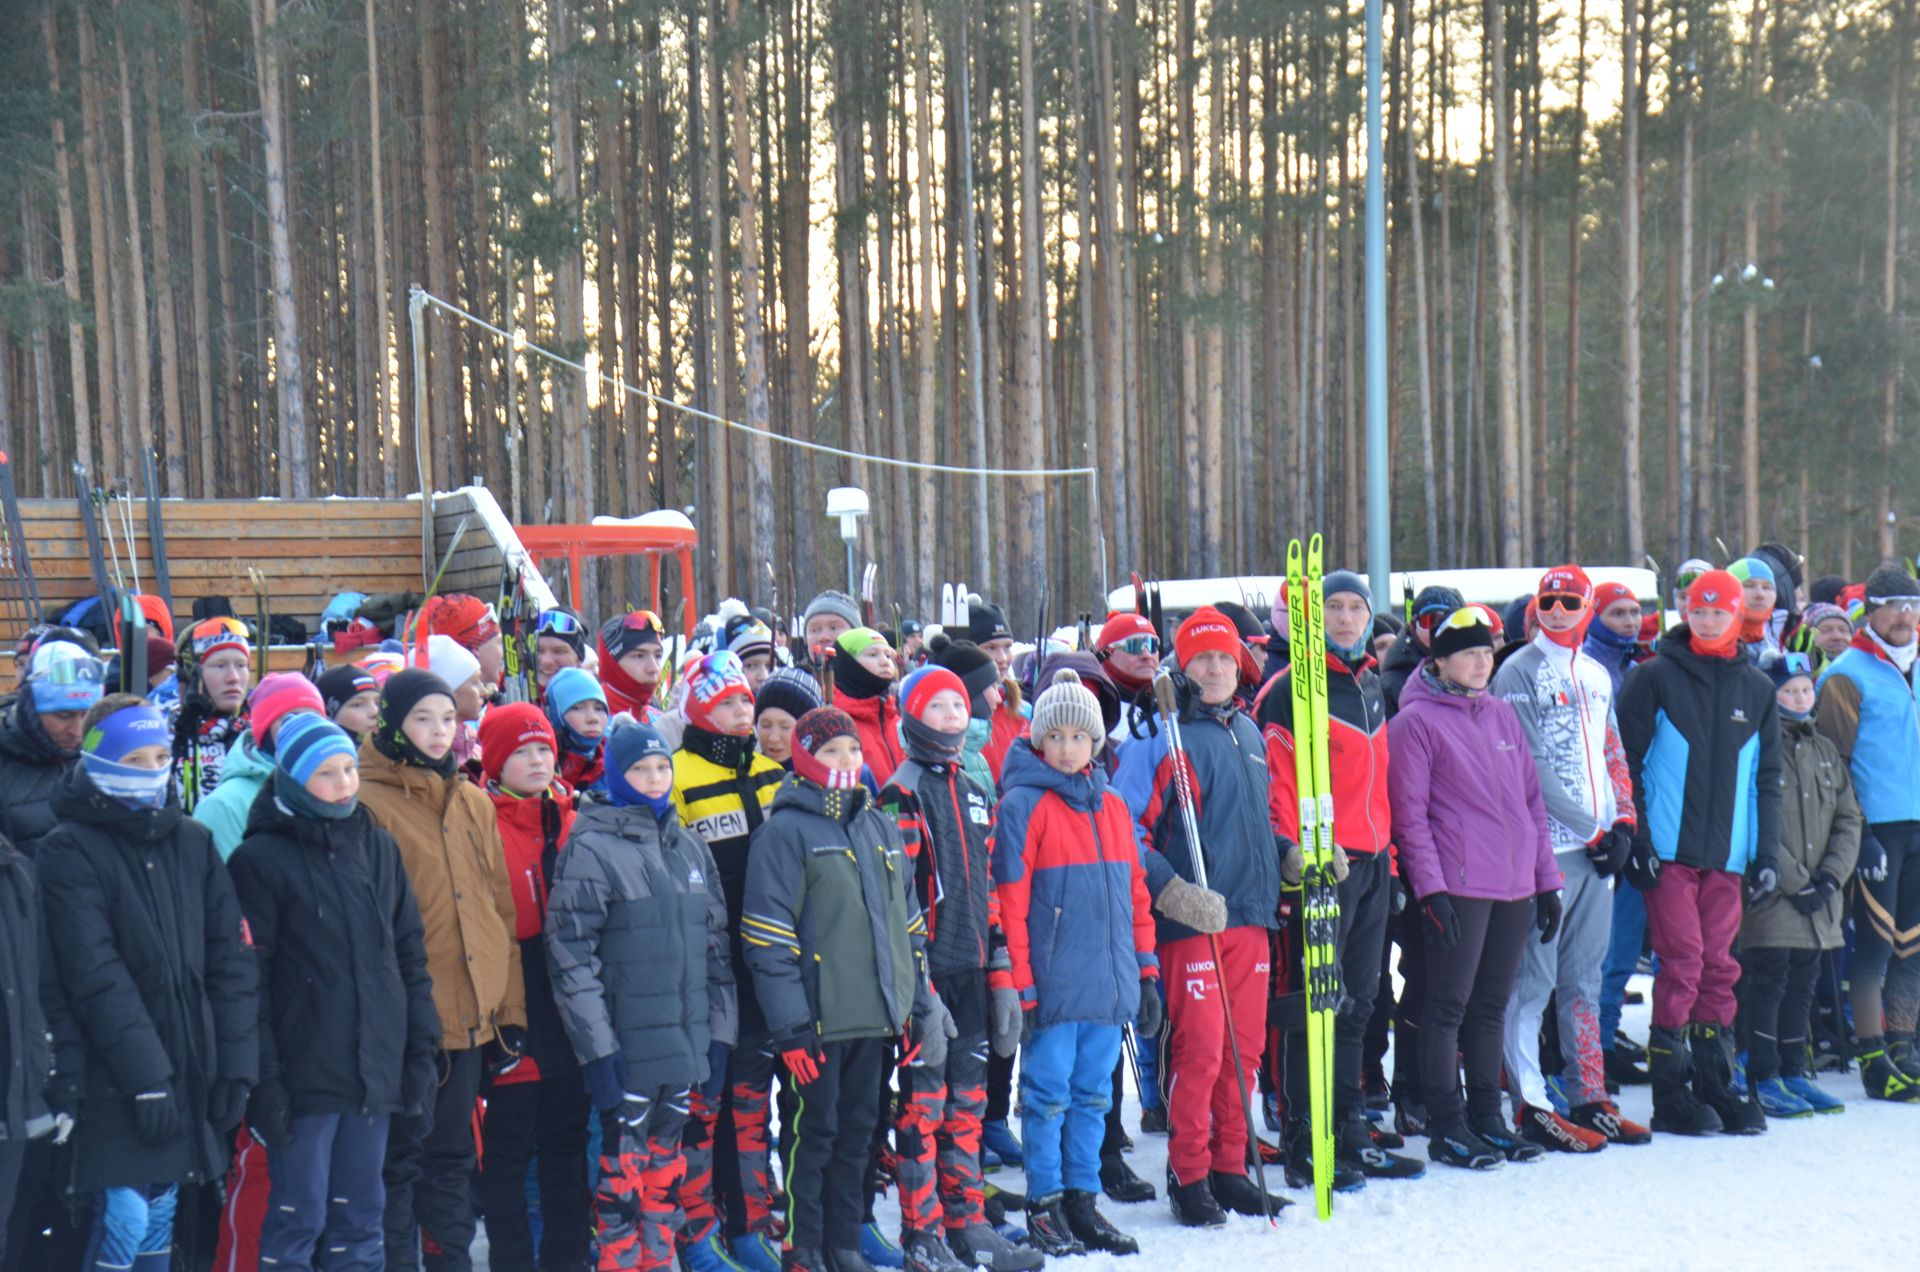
[{"left": 1114, "top": 605, "right": 1283, "bottom": 1226}]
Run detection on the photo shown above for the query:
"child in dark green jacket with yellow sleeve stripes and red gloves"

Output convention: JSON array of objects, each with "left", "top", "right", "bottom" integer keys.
[{"left": 741, "top": 707, "right": 952, "bottom": 1272}]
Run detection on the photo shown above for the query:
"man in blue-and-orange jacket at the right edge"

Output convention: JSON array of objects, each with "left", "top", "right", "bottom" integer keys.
[{"left": 1814, "top": 565, "right": 1920, "bottom": 1103}]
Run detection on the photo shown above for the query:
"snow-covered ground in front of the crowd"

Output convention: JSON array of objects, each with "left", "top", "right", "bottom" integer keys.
[{"left": 476, "top": 978, "right": 1920, "bottom": 1272}]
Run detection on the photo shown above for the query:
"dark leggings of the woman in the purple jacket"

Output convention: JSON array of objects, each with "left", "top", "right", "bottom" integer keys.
[{"left": 1421, "top": 897, "right": 1534, "bottom": 1126}]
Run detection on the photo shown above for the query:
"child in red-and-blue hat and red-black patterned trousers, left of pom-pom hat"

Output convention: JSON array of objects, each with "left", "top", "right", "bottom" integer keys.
[{"left": 879, "top": 667, "right": 1043, "bottom": 1268}]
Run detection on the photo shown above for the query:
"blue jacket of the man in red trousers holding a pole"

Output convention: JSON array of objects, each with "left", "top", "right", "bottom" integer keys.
[{"left": 1114, "top": 709, "right": 1281, "bottom": 945}]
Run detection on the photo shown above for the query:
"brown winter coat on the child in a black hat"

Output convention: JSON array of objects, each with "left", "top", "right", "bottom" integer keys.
[{"left": 359, "top": 738, "right": 526, "bottom": 1051}]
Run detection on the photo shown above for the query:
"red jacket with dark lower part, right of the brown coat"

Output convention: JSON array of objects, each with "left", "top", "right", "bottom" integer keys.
[{"left": 486, "top": 782, "right": 574, "bottom": 1086}]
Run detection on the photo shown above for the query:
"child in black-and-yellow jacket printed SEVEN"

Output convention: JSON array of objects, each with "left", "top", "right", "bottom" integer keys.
[{"left": 674, "top": 649, "right": 781, "bottom": 1268}]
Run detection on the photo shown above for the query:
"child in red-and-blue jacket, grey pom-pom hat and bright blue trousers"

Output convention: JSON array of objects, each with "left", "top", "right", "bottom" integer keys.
[{"left": 993, "top": 671, "right": 1160, "bottom": 1255}]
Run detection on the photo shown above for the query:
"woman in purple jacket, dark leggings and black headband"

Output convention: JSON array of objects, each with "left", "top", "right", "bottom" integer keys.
[{"left": 1386, "top": 605, "right": 1561, "bottom": 1170}]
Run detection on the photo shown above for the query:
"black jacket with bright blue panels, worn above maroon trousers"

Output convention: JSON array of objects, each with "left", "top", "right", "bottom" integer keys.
[{"left": 1615, "top": 623, "right": 1780, "bottom": 874}]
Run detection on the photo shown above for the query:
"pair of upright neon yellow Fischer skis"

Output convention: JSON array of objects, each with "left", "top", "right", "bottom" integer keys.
[{"left": 1286, "top": 534, "right": 1340, "bottom": 1218}]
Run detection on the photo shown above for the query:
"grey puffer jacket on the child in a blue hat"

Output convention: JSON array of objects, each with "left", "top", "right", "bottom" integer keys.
[{"left": 545, "top": 799, "right": 739, "bottom": 1089}]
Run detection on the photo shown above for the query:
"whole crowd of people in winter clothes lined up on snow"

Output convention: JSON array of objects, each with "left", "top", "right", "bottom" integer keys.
[{"left": 0, "top": 544, "right": 1920, "bottom": 1272}]
